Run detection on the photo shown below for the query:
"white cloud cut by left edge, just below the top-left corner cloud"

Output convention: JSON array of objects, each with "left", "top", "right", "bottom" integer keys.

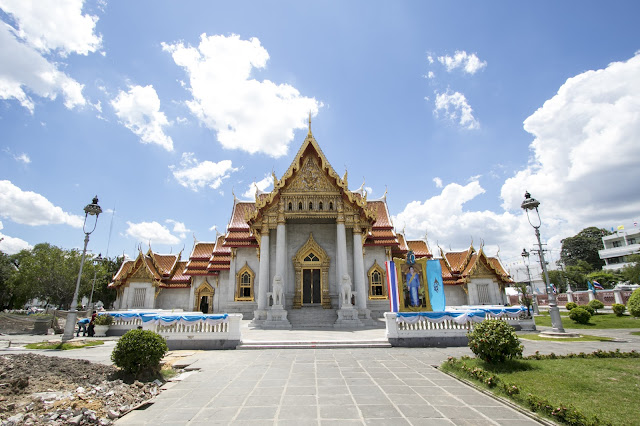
[{"left": 0, "top": 22, "right": 86, "bottom": 113}]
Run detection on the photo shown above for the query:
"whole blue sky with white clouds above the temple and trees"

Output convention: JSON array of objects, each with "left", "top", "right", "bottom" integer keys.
[{"left": 0, "top": 0, "right": 640, "bottom": 278}]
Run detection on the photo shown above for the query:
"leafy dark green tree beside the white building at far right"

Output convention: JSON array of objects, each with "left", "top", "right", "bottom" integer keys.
[{"left": 560, "top": 226, "right": 611, "bottom": 270}]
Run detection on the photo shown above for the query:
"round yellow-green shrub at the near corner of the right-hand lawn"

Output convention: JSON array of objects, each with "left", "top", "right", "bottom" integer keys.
[{"left": 467, "top": 320, "right": 522, "bottom": 363}]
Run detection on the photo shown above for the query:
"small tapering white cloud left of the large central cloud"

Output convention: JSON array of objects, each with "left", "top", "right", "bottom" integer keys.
[{"left": 111, "top": 85, "right": 173, "bottom": 151}]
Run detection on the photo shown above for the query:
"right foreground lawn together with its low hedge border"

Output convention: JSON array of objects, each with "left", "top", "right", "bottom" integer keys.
[{"left": 441, "top": 358, "right": 640, "bottom": 426}]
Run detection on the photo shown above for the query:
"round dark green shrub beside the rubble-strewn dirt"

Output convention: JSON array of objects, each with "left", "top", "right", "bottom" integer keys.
[{"left": 111, "top": 330, "right": 168, "bottom": 375}]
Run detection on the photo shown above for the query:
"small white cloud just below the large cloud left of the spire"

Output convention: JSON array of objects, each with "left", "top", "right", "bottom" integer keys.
[{"left": 169, "top": 152, "right": 238, "bottom": 191}]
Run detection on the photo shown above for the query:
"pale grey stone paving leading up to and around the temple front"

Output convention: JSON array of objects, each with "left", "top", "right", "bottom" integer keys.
[{"left": 0, "top": 322, "right": 640, "bottom": 426}]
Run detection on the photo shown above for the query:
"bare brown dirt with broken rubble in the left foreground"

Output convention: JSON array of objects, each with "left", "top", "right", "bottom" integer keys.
[{"left": 0, "top": 354, "right": 162, "bottom": 426}]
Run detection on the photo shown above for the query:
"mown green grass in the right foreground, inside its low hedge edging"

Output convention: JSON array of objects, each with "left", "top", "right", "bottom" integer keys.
[{"left": 441, "top": 358, "right": 640, "bottom": 425}]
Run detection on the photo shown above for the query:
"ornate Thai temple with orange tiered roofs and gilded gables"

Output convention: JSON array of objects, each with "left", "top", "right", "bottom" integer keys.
[{"left": 110, "top": 127, "right": 512, "bottom": 328}]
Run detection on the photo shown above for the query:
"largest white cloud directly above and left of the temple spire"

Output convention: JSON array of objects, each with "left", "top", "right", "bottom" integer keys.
[{"left": 162, "top": 34, "right": 321, "bottom": 158}]
